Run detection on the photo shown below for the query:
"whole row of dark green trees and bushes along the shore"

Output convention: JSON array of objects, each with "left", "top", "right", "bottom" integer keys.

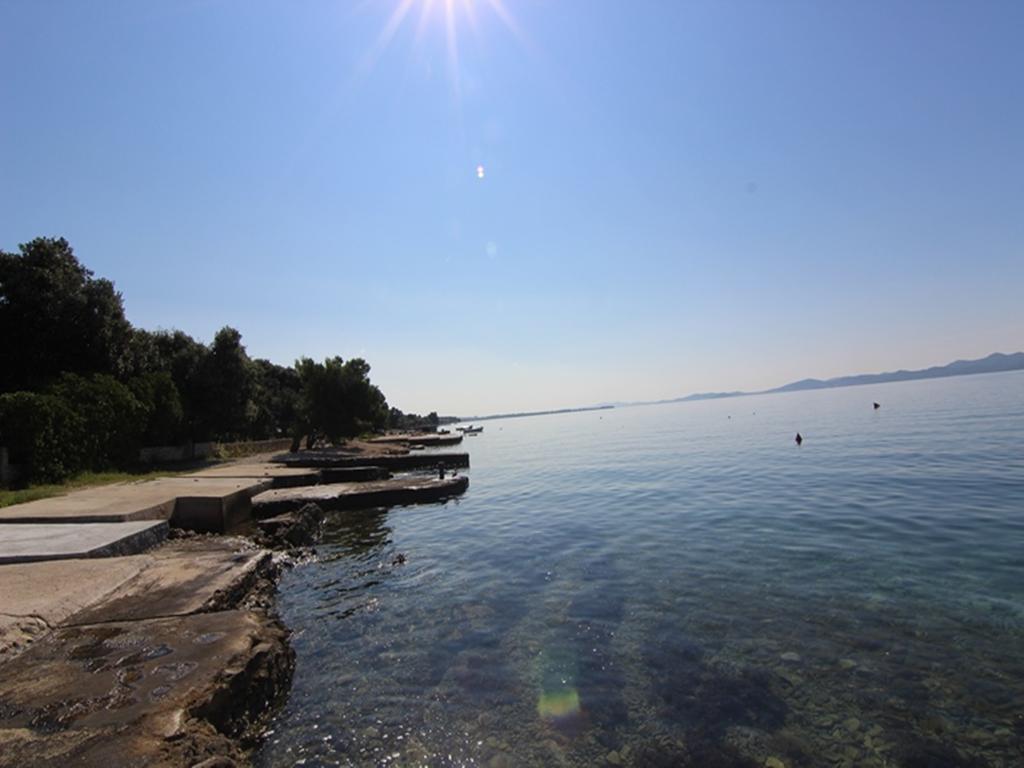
[{"left": 0, "top": 238, "right": 421, "bottom": 481}]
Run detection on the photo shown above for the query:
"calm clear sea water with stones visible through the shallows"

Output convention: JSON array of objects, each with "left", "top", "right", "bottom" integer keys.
[{"left": 256, "top": 373, "right": 1024, "bottom": 768}]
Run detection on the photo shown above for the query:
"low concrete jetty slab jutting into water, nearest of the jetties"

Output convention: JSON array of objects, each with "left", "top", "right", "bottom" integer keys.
[{"left": 253, "top": 475, "right": 469, "bottom": 519}]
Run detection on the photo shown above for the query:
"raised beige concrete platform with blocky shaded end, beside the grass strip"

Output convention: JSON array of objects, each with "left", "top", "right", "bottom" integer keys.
[{"left": 0, "top": 477, "right": 270, "bottom": 531}]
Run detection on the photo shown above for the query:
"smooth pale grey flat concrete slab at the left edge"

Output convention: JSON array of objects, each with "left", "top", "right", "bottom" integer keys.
[{"left": 0, "top": 520, "right": 168, "bottom": 569}]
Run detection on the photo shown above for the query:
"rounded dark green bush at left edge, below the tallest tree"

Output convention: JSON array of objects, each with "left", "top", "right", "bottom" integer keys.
[{"left": 0, "top": 392, "right": 83, "bottom": 482}]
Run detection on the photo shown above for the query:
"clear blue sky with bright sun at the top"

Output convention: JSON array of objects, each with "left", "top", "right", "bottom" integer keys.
[{"left": 0, "top": 0, "right": 1024, "bottom": 415}]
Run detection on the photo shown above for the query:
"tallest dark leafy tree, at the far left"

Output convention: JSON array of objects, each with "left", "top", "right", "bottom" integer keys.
[{"left": 0, "top": 238, "right": 131, "bottom": 391}]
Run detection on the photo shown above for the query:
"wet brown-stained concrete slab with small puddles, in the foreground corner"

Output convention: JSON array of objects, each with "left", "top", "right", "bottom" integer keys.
[{"left": 0, "top": 610, "right": 293, "bottom": 768}]
